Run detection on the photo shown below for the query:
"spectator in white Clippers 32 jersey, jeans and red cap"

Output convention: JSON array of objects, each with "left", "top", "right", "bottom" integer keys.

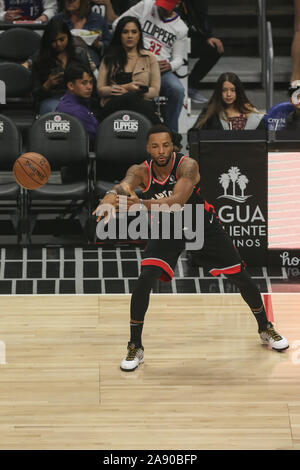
[{"left": 113, "top": 0, "right": 188, "bottom": 133}]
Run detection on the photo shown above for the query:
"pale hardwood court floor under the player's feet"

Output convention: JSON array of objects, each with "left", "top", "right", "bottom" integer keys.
[{"left": 0, "top": 294, "right": 300, "bottom": 450}]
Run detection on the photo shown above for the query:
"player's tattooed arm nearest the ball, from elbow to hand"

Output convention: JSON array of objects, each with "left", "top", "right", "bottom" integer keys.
[{"left": 93, "top": 164, "right": 147, "bottom": 222}]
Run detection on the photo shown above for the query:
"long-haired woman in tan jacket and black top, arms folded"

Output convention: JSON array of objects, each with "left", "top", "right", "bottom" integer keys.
[{"left": 97, "top": 16, "right": 160, "bottom": 124}]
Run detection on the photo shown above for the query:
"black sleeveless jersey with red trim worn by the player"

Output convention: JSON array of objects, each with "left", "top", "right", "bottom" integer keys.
[{"left": 143, "top": 152, "right": 204, "bottom": 204}]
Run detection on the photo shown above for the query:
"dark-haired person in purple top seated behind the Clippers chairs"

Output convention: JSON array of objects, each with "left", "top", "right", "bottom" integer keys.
[{"left": 56, "top": 64, "right": 99, "bottom": 144}]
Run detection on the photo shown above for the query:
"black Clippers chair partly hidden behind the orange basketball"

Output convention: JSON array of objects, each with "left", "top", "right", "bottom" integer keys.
[{"left": 28, "top": 112, "right": 92, "bottom": 241}]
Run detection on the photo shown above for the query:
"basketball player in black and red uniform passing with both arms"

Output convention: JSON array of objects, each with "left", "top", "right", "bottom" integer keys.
[{"left": 93, "top": 125, "right": 289, "bottom": 371}]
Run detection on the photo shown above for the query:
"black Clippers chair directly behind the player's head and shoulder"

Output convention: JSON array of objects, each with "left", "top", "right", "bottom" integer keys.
[{"left": 94, "top": 110, "right": 152, "bottom": 198}]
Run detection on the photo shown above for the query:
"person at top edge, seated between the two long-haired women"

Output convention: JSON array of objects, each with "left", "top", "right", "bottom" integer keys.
[{"left": 56, "top": 0, "right": 111, "bottom": 68}]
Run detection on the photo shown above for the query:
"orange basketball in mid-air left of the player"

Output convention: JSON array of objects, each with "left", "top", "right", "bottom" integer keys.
[{"left": 13, "top": 152, "right": 51, "bottom": 189}]
